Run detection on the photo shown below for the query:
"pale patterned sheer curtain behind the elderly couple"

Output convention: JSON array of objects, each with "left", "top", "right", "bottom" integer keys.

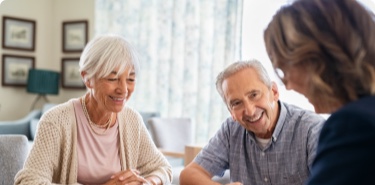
[{"left": 95, "top": 0, "right": 243, "bottom": 142}]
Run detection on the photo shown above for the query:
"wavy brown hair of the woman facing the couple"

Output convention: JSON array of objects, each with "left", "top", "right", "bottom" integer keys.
[{"left": 264, "top": 0, "right": 375, "bottom": 110}]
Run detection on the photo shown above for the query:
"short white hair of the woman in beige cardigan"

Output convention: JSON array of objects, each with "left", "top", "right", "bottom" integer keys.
[{"left": 79, "top": 34, "right": 139, "bottom": 80}]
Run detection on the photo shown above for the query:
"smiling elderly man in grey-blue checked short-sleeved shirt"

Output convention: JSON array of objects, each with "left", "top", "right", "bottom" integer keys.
[{"left": 180, "top": 60, "right": 325, "bottom": 185}]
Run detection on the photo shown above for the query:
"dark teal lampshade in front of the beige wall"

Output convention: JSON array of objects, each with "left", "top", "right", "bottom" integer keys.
[{"left": 27, "top": 69, "right": 60, "bottom": 94}]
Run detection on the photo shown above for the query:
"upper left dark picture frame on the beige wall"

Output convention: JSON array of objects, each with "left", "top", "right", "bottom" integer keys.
[{"left": 2, "top": 16, "right": 36, "bottom": 51}]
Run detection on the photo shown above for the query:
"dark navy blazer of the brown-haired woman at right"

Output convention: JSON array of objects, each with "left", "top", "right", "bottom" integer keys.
[{"left": 307, "top": 96, "right": 375, "bottom": 185}]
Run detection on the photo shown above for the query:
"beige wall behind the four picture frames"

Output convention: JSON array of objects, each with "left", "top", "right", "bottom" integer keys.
[{"left": 0, "top": 0, "right": 95, "bottom": 121}]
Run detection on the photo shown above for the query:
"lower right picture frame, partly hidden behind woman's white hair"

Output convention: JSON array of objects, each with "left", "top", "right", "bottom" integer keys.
[{"left": 61, "top": 58, "right": 86, "bottom": 89}]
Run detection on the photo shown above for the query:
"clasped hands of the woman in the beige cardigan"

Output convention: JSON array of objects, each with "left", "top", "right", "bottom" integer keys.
[{"left": 105, "top": 169, "right": 154, "bottom": 185}]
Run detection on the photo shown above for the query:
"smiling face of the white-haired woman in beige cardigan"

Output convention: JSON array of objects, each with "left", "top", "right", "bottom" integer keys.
[{"left": 89, "top": 67, "right": 135, "bottom": 112}]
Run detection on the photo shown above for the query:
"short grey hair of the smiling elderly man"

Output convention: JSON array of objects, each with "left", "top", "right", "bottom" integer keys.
[{"left": 216, "top": 59, "right": 272, "bottom": 102}]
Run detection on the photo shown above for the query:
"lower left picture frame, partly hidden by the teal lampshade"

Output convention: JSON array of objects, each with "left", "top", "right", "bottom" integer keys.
[{"left": 1, "top": 54, "right": 35, "bottom": 87}]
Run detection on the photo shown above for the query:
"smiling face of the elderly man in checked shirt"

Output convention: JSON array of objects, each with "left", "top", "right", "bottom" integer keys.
[{"left": 222, "top": 68, "right": 279, "bottom": 138}]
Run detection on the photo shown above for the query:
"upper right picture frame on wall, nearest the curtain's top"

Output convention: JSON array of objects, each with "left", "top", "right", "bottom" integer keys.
[{"left": 62, "top": 20, "right": 88, "bottom": 53}]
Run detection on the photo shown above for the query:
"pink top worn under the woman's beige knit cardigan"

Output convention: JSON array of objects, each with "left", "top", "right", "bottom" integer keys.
[{"left": 74, "top": 99, "right": 121, "bottom": 184}]
